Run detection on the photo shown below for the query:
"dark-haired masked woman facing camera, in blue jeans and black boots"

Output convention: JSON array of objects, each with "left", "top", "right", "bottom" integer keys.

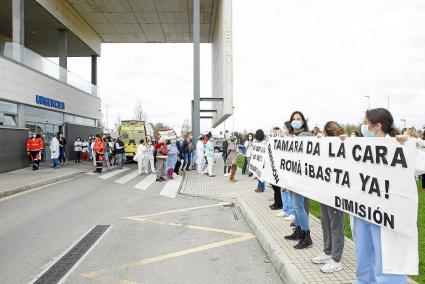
[{"left": 285, "top": 111, "right": 313, "bottom": 249}]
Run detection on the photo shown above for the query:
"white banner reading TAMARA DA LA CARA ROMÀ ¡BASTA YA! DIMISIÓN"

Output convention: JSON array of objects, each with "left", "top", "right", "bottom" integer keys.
[{"left": 261, "top": 137, "right": 418, "bottom": 236}]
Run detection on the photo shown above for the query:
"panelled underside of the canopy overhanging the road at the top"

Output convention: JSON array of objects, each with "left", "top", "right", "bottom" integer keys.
[{"left": 66, "top": 0, "right": 217, "bottom": 42}]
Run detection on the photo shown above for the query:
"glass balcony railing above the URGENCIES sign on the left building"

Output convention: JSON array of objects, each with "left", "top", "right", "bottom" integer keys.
[{"left": 0, "top": 37, "right": 98, "bottom": 96}]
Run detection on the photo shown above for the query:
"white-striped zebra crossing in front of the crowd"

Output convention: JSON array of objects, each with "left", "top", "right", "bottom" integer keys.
[{"left": 86, "top": 167, "right": 182, "bottom": 198}]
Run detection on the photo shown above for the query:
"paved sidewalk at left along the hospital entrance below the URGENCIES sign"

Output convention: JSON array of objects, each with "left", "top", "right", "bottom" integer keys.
[{"left": 0, "top": 161, "right": 93, "bottom": 197}]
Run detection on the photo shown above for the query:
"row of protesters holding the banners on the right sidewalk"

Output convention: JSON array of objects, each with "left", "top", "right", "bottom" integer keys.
[{"left": 235, "top": 108, "right": 425, "bottom": 283}]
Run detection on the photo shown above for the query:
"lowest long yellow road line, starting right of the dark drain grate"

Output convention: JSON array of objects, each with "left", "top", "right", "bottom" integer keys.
[{"left": 81, "top": 233, "right": 255, "bottom": 279}]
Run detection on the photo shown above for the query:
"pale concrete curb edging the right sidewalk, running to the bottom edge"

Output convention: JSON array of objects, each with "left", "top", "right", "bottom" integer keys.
[{"left": 238, "top": 197, "right": 308, "bottom": 284}]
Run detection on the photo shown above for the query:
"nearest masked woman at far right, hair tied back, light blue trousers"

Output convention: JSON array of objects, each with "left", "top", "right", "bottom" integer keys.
[{"left": 353, "top": 108, "right": 425, "bottom": 284}]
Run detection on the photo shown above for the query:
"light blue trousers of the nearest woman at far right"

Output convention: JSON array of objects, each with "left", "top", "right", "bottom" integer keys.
[{"left": 353, "top": 217, "right": 407, "bottom": 284}]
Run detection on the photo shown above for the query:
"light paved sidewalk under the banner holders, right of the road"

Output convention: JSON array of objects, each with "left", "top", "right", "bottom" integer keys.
[{"left": 180, "top": 156, "right": 404, "bottom": 283}]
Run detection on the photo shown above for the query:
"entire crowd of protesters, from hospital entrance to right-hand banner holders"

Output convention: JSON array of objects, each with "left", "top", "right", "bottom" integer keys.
[{"left": 27, "top": 108, "right": 425, "bottom": 283}]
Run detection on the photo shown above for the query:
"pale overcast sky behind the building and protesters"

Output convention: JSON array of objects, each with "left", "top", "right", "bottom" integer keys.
[{"left": 69, "top": 0, "right": 425, "bottom": 134}]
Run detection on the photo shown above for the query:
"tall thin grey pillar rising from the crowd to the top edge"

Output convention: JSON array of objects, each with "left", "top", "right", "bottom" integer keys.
[{"left": 192, "top": 0, "right": 201, "bottom": 141}]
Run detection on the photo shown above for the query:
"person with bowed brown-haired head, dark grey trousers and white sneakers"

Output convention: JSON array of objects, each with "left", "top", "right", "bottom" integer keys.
[{"left": 311, "top": 121, "right": 345, "bottom": 273}]
